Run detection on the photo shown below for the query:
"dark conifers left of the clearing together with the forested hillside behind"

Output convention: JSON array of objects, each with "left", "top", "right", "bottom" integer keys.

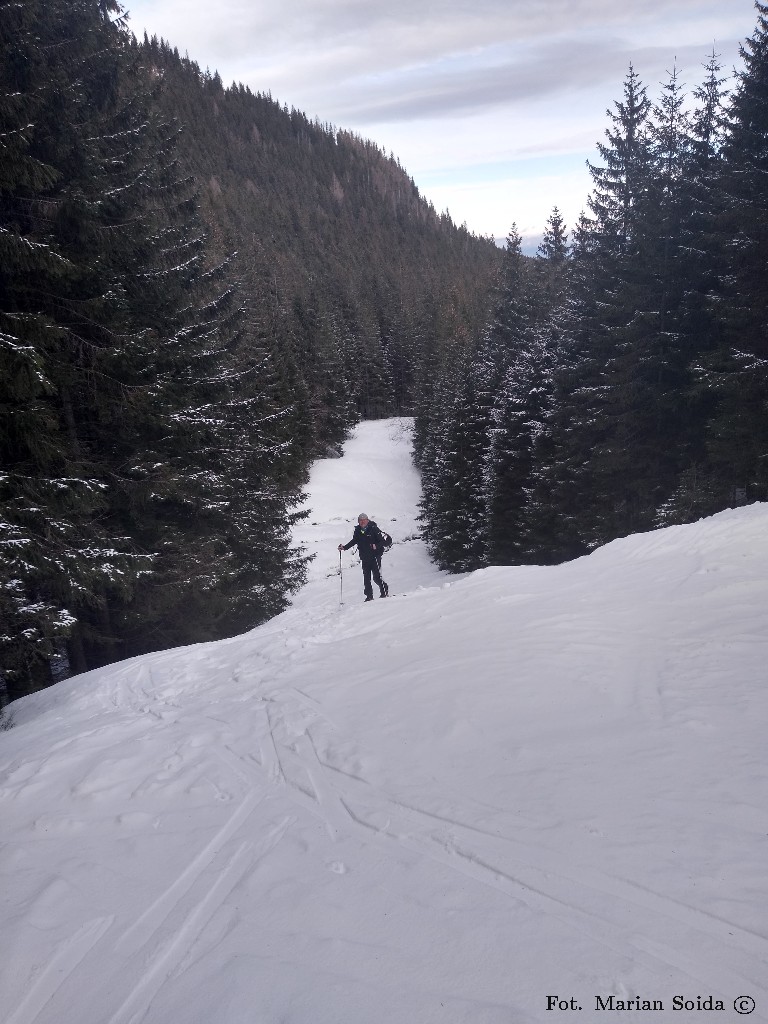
[{"left": 0, "top": 0, "right": 502, "bottom": 705}]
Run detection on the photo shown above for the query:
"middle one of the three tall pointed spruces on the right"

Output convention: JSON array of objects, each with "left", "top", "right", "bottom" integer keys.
[{"left": 609, "top": 69, "right": 695, "bottom": 530}]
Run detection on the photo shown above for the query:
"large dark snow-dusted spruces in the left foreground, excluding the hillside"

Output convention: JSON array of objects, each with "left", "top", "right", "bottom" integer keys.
[{"left": 0, "top": 0, "right": 311, "bottom": 695}]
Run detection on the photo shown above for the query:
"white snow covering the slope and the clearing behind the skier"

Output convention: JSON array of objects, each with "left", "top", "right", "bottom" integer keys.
[{"left": 0, "top": 421, "right": 768, "bottom": 1024}]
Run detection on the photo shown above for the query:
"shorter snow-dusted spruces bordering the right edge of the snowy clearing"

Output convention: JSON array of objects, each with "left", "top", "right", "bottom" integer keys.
[{"left": 417, "top": 224, "right": 548, "bottom": 570}]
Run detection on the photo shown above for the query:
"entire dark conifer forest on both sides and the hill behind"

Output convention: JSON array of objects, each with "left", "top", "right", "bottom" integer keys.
[{"left": 0, "top": 0, "right": 768, "bottom": 705}]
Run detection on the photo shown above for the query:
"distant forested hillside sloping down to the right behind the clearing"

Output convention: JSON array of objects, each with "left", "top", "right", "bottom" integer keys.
[{"left": 139, "top": 33, "right": 500, "bottom": 436}]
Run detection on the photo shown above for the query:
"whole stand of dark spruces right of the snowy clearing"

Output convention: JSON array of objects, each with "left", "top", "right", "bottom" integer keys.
[{"left": 416, "top": 2, "right": 768, "bottom": 571}]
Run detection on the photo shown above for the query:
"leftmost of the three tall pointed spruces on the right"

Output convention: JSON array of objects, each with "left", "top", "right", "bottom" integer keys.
[{"left": 550, "top": 67, "right": 651, "bottom": 553}]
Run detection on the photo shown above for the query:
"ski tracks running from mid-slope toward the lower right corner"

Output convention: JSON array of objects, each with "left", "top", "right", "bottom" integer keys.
[{"left": 202, "top": 679, "right": 768, "bottom": 1007}]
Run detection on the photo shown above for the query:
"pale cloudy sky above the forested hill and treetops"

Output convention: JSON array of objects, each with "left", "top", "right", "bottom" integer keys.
[{"left": 126, "top": 0, "right": 757, "bottom": 246}]
